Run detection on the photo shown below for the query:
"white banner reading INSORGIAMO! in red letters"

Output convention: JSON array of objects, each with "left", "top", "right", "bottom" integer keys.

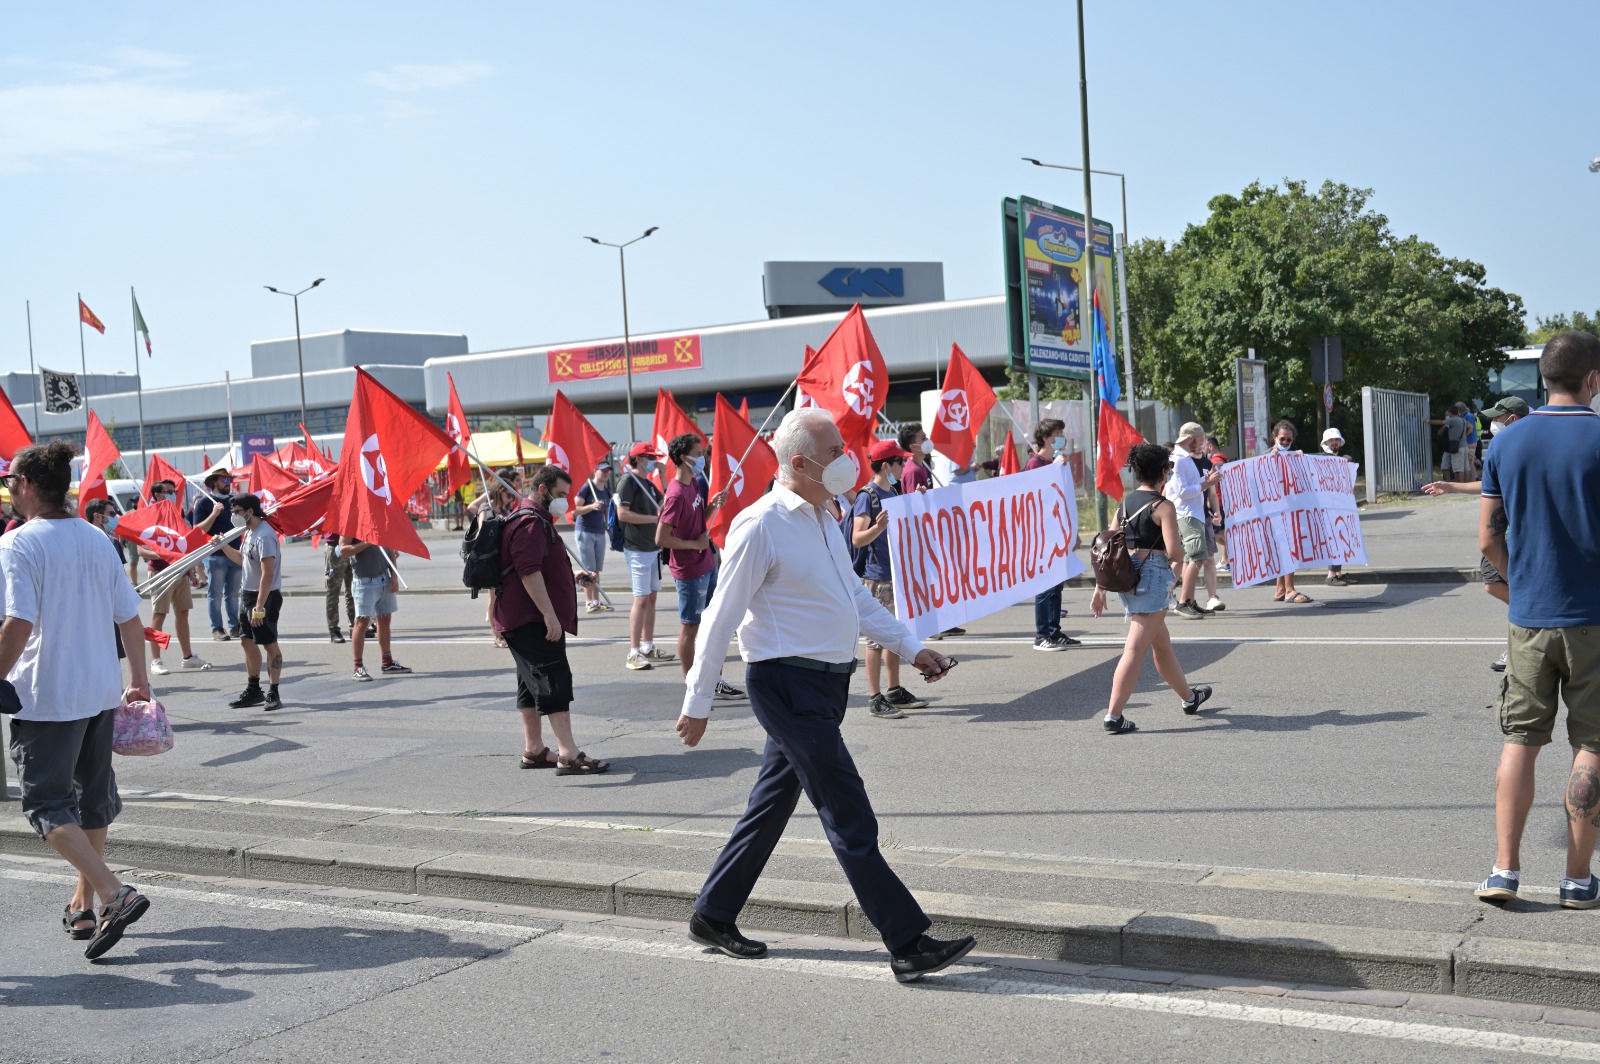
[{"left": 883, "top": 462, "right": 1085, "bottom": 638}]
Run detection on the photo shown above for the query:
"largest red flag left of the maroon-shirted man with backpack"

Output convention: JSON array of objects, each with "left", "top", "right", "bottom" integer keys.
[{"left": 326, "top": 366, "right": 451, "bottom": 558}]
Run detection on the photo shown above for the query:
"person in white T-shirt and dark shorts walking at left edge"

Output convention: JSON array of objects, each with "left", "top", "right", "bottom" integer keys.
[{"left": 0, "top": 440, "right": 150, "bottom": 960}]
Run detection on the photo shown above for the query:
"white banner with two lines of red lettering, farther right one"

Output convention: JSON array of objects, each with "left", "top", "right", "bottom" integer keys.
[{"left": 1218, "top": 451, "right": 1366, "bottom": 587}]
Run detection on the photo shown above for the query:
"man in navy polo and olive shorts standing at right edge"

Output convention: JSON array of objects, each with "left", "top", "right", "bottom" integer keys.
[{"left": 1477, "top": 331, "right": 1600, "bottom": 909}]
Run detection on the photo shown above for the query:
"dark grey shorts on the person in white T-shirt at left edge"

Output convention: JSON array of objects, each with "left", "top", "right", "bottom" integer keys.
[{"left": 10, "top": 709, "right": 122, "bottom": 838}]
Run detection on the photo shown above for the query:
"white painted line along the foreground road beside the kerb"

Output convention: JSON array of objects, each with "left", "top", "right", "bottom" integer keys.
[{"left": 0, "top": 869, "right": 1600, "bottom": 1061}]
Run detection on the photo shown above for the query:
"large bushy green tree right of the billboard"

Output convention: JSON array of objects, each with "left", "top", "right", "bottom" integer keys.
[{"left": 1128, "top": 181, "right": 1523, "bottom": 429}]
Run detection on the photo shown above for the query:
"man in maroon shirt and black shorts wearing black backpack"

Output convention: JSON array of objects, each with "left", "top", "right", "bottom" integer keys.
[{"left": 490, "top": 466, "right": 611, "bottom": 776}]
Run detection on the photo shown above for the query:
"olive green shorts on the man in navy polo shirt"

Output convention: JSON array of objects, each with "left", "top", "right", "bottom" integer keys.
[{"left": 1499, "top": 624, "right": 1600, "bottom": 754}]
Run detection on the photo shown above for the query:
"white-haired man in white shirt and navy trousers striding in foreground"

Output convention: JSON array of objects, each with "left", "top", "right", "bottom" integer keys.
[{"left": 677, "top": 406, "right": 976, "bottom": 982}]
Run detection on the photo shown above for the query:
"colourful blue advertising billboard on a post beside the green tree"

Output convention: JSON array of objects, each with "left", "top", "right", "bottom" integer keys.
[{"left": 1006, "top": 195, "right": 1118, "bottom": 381}]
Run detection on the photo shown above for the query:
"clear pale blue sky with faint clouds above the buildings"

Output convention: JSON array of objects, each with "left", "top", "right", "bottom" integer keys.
[{"left": 0, "top": 0, "right": 1600, "bottom": 386}]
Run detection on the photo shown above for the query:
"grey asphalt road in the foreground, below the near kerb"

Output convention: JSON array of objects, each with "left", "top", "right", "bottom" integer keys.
[{"left": 0, "top": 859, "right": 1600, "bottom": 1064}]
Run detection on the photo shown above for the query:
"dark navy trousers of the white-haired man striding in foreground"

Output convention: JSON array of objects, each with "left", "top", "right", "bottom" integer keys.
[{"left": 694, "top": 661, "right": 931, "bottom": 949}]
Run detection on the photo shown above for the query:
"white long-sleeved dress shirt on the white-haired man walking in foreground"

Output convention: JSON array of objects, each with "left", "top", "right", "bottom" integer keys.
[{"left": 683, "top": 483, "right": 923, "bottom": 718}]
